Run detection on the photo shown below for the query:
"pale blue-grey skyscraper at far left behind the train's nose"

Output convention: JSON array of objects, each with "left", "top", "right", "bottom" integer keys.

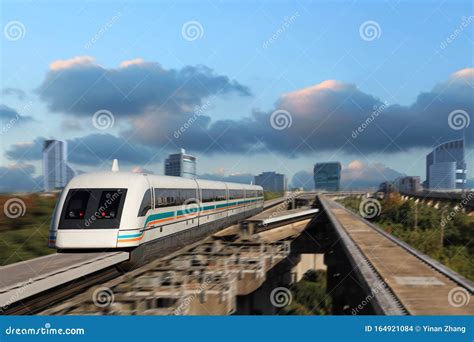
[{"left": 43, "top": 140, "right": 75, "bottom": 191}]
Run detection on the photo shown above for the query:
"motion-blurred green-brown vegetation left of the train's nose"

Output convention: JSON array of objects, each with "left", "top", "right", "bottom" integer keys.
[{"left": 0, "top": 194, "right": 57, "bottom": 266}]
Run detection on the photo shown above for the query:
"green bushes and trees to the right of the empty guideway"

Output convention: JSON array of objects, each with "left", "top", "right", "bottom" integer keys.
[{"left": 339, "top": 194, "right": 474, "bottom": 280}]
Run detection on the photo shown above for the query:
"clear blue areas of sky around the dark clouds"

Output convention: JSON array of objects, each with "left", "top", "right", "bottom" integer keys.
[{"left": 0, "top": 1, "right": 474, "bottom": 191}]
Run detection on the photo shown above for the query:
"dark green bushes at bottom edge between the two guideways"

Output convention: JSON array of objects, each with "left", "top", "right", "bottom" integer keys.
[{"left": 281, "top": 270, "right": 331, "bottom": 315}]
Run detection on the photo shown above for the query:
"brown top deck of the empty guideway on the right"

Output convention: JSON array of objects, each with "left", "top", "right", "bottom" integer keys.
[{"left": 320, "top": 196, "right": 474, "bottom": 315}]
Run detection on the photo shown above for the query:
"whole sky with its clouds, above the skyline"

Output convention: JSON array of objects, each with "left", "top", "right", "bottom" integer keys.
[{"left": 0, "top": 1, "right": 474, "bottom": 189}]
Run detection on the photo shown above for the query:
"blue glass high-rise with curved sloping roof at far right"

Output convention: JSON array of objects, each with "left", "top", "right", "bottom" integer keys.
[{"left": 426, "top": 139, "right": 466, "bottom": 190}]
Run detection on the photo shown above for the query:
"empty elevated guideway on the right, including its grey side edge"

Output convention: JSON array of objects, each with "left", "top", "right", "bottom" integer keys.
[{"left": 319, "top": 196, "right": 474, "bottom": 315}]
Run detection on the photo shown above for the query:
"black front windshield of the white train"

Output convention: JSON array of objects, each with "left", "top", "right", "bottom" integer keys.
[{"left": 59, "top": 189, "right": 127, "bottom": 229}]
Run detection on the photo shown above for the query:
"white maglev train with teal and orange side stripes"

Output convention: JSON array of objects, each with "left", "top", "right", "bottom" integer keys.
[{"left": 49, "top": 163, "right": 263, "bottom": 263}]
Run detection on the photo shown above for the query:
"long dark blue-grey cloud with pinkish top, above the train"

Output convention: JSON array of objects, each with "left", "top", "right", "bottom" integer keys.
[{"left": 37, "top": 56, "right": 250, "bottom": 117}]
